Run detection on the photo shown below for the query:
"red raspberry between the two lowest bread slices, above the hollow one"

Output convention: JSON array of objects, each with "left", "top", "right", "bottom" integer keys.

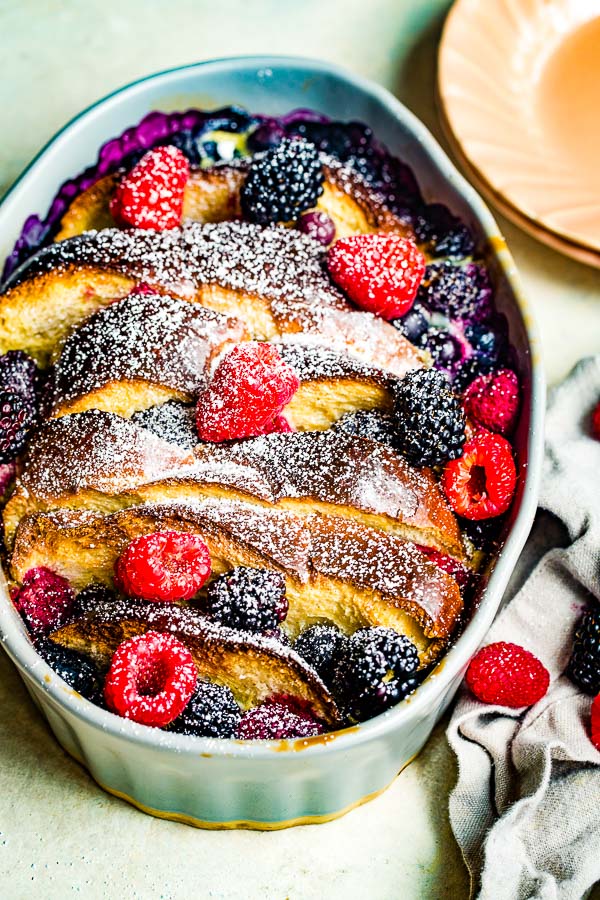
[{"left": 115, "top": 531, "right": 210, "bottom": 600}]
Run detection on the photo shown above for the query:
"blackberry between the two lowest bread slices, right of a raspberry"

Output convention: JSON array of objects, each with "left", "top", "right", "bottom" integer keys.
[{"left": 206, "top": 566, "right": 288, "bottom": 634}]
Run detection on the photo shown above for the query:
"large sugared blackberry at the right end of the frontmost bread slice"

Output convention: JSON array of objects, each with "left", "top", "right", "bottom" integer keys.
[{"left": 332, "top": 627, "right": 419, "bottom": 722}]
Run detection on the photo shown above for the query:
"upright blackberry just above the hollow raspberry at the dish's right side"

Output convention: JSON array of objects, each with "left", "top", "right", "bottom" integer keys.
[{"left": 394, "top": 369, "right": 466, "bottom": 466}]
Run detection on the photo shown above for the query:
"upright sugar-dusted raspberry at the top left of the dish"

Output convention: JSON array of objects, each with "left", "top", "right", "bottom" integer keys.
[{"left": 110, "top": 146, "right": 190, "bottom": 231}]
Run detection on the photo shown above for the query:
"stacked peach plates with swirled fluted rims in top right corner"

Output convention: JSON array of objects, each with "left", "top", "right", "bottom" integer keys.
[{"left": 438, "top": 0, "right": 600, "bottom": 268}]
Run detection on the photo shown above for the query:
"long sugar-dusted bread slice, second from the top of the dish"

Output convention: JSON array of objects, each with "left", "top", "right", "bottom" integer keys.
[{"left": 0, "top": 222, "right": 427, "bottom": 375}]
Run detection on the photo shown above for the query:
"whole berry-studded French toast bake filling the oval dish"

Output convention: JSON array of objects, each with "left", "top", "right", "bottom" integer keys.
[{"left": 0, "top": 105, "right": 519, "bottom": 739}]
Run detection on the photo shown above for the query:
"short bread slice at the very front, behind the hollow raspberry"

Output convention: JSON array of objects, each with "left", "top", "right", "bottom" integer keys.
[{"left": 50, "top": 599, "right": 340, "bottom": 727}]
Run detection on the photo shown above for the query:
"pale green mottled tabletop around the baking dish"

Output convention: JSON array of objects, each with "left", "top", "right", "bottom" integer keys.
[{"left": 0, "top": 0, "right": 600, "bottom": 900}]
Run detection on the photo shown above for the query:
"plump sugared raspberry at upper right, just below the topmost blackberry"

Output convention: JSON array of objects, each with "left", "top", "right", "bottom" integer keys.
[{"left": 327, "top": 234, "right": 425, "bottom": 319}]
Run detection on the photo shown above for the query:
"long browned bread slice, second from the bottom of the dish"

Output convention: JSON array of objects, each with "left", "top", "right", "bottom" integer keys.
[{"left": 11, "top": 500, "right": 462, "bottom": 664}]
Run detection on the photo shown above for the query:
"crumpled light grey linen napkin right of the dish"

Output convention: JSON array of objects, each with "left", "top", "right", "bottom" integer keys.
[{"left": 447, "top": 356, "right": 600, "bottom": 900}]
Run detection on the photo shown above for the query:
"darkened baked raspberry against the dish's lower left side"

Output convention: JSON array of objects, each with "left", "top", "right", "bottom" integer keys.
[{"left": 13, "top": 566, "right": 75, "bottom": 637}]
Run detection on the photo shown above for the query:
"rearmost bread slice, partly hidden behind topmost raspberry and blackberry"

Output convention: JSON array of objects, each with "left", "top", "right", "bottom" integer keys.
[{"left": 55, "top": 156, "right": 412, "bottom": 241}]
